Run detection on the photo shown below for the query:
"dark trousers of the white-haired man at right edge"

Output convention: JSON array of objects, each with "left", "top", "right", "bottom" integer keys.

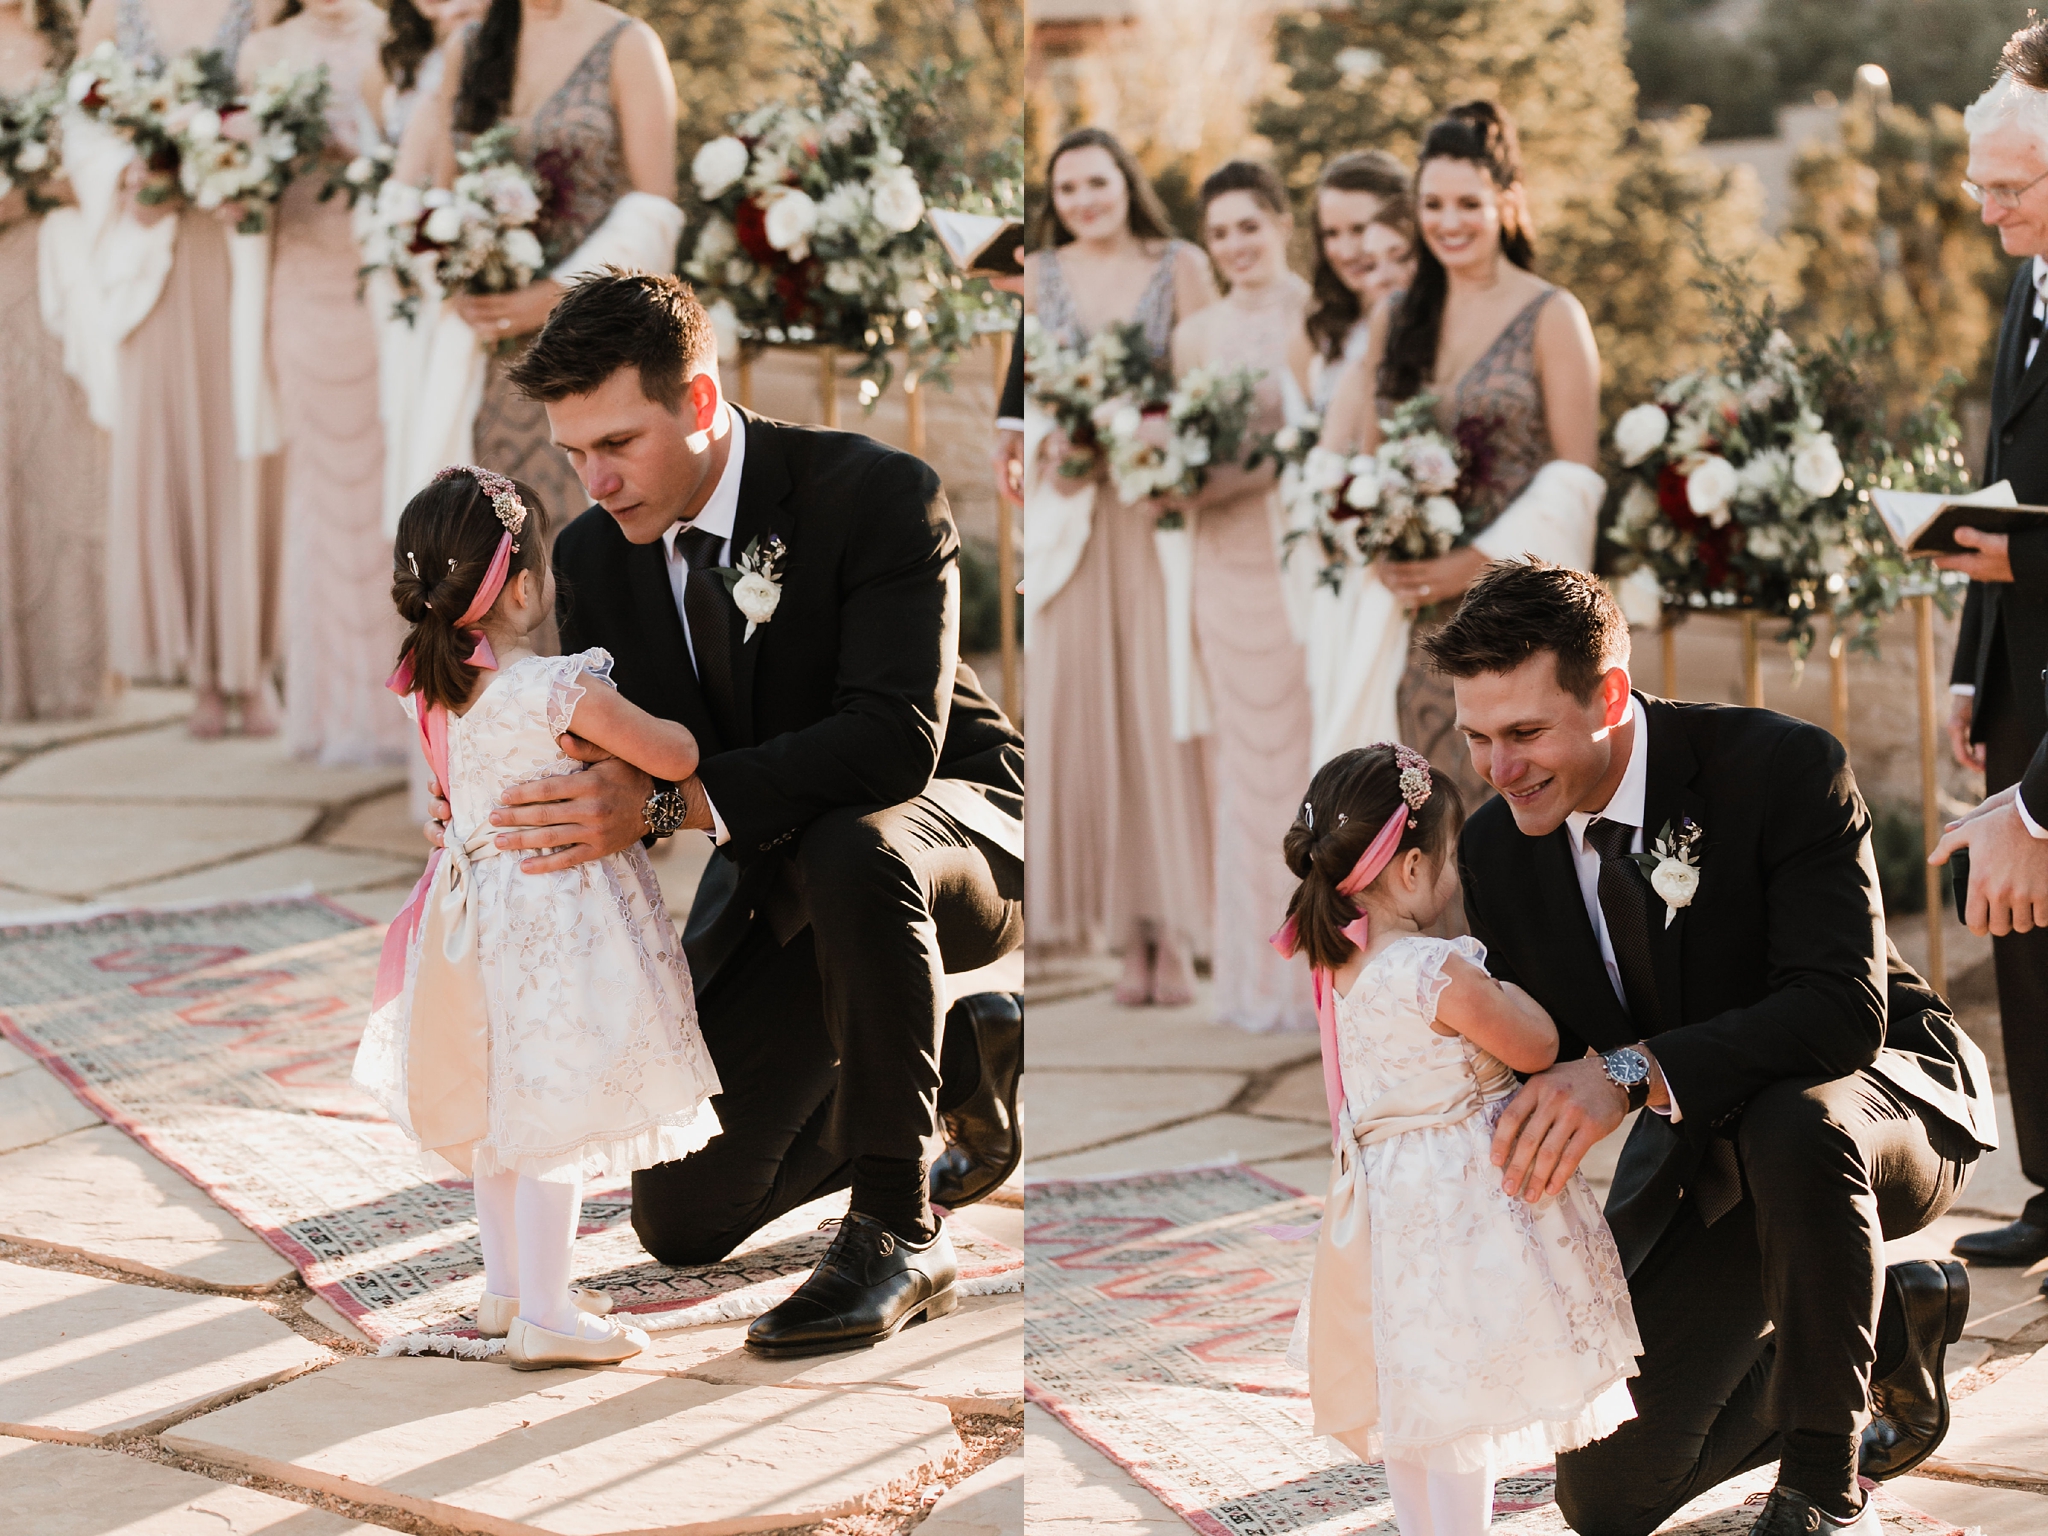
[{"left": 1985, "top": 655, "right": 2048, "bottom": 1227}]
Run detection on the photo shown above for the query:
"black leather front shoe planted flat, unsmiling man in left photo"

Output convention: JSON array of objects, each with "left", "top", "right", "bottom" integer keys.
[{"left": 748, "top": 1212, "right": 961, "bottom": 1358}]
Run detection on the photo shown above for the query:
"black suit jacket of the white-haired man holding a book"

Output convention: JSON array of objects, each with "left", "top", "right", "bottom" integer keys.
[{"left": 1950, "top": 260, "right": 2048, "bottom": 761}]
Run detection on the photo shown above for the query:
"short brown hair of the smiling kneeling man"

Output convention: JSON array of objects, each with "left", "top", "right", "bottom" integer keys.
[{"left": 1421, "top": 559, "right": 1628, "bottom": 705}]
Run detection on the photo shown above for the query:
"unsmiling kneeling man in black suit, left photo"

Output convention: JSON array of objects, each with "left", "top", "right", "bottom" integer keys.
[{"left": 475, "top": 272, "right": 1024, "bottom": 1354}]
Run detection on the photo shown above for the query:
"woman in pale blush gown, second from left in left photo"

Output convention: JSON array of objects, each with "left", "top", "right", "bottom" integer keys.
[{"left": 78, "top": 0, "right": 279, "bottom": 737}]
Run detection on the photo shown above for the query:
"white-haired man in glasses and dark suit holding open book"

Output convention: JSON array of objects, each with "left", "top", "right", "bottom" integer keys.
[{"left": 1935, "top": 23, "right": 2048, "bottom": 1264}]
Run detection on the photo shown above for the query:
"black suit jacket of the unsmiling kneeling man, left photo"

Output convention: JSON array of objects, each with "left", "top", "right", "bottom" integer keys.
[{"left": 555, "top": 412, "right": 1024, "bottom": 985}]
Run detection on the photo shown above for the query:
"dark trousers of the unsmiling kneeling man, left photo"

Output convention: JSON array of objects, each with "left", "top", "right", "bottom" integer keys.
[{"left": 614, "top": 797, "right": 1024, "bottom": 1264}]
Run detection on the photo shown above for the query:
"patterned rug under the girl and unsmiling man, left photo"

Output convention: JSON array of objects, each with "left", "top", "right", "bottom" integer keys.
[{"left": 0, "top": 899, "right": 1022, "bottom": 1341}]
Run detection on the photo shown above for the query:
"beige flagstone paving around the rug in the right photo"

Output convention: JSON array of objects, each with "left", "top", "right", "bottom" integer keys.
[{"left": 1024, "top": 958, "right": 2048, "bottom": 1536}]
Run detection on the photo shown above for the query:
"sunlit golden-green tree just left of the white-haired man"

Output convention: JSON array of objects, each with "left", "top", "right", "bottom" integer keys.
[{"left": 1784, "top": 106, "right": 2011, "bottom": 420}]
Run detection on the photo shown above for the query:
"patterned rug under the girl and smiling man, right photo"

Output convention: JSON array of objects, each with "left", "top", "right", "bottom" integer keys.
[{"left": 1024, "top": 1167, "right": 1960, "bottom": 1536}]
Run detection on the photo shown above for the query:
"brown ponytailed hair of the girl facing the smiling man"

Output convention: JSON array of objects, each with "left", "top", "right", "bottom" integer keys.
[{"left": 1280, "top": 741, "right": 1464, "bottom": 971}]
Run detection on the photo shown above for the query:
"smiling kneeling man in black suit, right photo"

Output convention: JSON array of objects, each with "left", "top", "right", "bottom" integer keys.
[{"left": 1423, "top": 563, "right": 1997, "bottom": 1536}]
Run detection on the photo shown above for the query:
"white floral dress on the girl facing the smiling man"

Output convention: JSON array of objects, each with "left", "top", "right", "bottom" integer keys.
[{"left": 1310, "top": 936, "right": 1642, "bottom": 1473}]
